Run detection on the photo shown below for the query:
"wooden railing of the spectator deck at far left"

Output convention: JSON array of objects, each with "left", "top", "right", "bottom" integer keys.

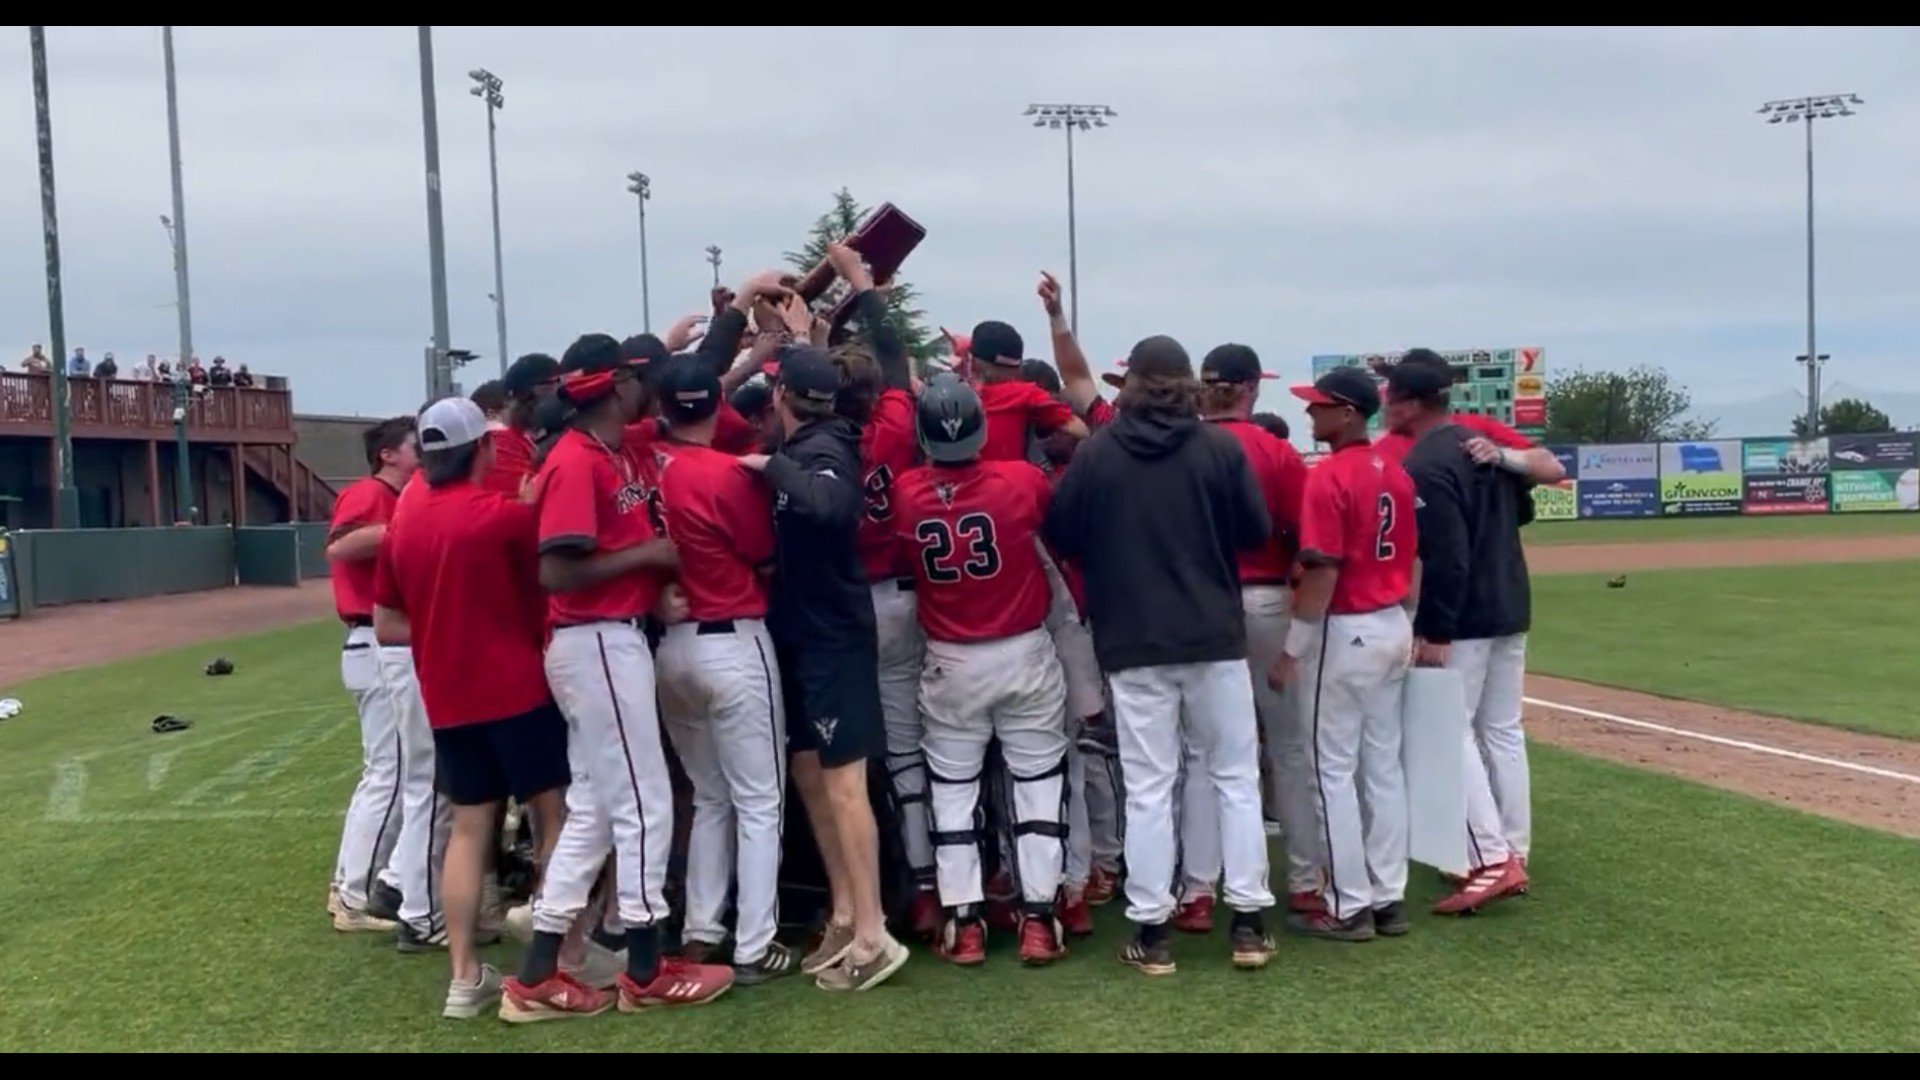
[{"left": 0, "top": 371, "right": 294, "bottom": 442}]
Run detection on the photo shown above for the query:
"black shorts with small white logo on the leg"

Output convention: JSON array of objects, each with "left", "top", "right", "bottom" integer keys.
[{"left": 776, "top": 644, "right": 887, "bottom": 769}]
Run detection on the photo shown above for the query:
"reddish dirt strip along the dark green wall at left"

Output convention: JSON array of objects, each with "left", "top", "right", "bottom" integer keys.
[{"left": 0, "top": 580, "right": 334, "bottom": 686}]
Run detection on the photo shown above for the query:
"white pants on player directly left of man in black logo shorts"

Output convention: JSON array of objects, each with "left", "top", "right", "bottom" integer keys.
[{"left": 657, "top": 619, "right": 787, "bottom": 965}]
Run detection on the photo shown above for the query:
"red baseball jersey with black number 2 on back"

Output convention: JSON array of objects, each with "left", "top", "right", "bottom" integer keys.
[{"left": 1300, "top": 442, "right": 1415, "bottom": 615}]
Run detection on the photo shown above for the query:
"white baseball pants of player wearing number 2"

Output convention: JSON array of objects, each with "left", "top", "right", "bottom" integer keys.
[{"left": 1296, "top": 605, "right": 1413, "bottom": 919}]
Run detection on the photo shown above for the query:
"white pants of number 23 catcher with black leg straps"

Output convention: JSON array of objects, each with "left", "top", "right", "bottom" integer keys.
[{"left": 920, "top": 628, "right": 1068, "bottom": 907}]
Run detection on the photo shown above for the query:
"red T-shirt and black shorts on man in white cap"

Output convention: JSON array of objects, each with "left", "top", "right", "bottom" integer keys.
[{"left": 374, "top": 480, "right": 570, "bottom": 805}]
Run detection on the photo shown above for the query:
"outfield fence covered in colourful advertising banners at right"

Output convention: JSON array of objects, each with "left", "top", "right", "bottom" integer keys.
[{"left": 1534, "top": 430, "right": 1920, "bottom": 521}]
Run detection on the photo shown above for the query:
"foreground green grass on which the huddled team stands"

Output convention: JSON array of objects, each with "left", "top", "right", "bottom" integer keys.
[{"left": 0, "top": 618, "right": 1920, "bottom": 1053}]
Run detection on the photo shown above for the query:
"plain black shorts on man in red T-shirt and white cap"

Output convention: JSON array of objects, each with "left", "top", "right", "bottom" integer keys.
[{"left": 434, "top": 701, "right": 572, "bottom": 807}]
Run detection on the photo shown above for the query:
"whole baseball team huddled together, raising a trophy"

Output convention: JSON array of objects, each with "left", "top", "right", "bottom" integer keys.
[{"left": 326, "top": 246, "right": 1561, "bottom": 1022}]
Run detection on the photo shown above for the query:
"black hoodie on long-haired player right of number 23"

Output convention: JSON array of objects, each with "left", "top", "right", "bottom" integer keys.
[{"left": 1046, "top": 409, "right": 1273, "bottom": 671}]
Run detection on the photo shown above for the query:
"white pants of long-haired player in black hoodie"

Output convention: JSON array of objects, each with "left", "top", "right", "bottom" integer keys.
[{"left": 1108, "top": 659, "right": 1273, "bottom": 924}]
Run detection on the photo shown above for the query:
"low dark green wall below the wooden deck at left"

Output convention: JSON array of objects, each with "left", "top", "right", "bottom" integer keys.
[{"left": 0, "top": 523, "right": 326, "bottom": 617}]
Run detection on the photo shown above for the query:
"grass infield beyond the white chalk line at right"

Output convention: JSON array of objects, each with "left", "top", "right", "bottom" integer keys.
[{"left": 1526, "top": 561, "right": 1920, "bottom": 738}]
